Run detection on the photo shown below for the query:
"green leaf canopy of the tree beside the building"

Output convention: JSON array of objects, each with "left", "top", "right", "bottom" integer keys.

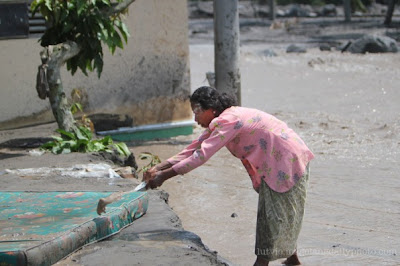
[{"left": 31, "top": 0, "right": 129, "bottom": 77}]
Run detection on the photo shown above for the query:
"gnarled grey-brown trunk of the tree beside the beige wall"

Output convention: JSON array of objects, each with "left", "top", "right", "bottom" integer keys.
[{"left": 42, "top": 42, "right": 80, "bottom": 131}]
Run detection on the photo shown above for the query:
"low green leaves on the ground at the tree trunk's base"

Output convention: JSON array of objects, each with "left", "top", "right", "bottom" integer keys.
[{"left": 41, "top": 126, "right": 131, "bottom": 157}]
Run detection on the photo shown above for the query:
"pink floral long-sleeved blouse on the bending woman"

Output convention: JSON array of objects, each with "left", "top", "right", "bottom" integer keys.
[{"left": 167, "top": 106, "right": 314, "bottom": 192}]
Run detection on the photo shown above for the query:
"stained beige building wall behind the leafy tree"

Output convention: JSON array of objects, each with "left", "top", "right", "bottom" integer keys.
[{"left": 0, "top": 0, "right": 191, "bottom": 129}]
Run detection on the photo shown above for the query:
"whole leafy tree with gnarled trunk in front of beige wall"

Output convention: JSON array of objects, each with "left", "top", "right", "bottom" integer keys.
[{"left": 31, "top": 0, "right": 135, "bottom": 132}]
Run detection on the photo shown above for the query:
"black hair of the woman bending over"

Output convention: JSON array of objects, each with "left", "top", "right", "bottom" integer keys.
[{"left": 190, "top": 86, "right": 237, "bottom": 116}]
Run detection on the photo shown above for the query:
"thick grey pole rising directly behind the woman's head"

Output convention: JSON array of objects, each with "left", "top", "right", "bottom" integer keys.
[{"left": 214, "top": 0, "right": 241, "bottom": 105}]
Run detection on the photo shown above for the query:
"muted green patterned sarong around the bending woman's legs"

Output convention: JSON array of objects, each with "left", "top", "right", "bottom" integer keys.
[{"left": 255, "top": 165, "right": 310, "bottom": 261}]
